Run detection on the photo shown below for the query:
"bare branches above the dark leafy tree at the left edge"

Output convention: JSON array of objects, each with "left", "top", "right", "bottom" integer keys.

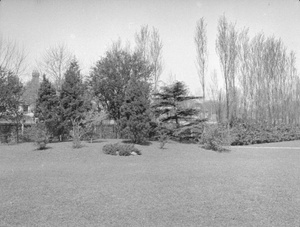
[{"left": 0, "top": 35, "right": 26, "bottom": 75}]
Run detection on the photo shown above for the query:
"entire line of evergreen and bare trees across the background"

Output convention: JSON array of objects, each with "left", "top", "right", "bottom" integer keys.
[{"left": 0, "top": 16, "right": 300, "bottom": 144}]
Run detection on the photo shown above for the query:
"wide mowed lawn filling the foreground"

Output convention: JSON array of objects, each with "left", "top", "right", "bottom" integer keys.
[{"left": 0, "top": 140, "right": 300, "bottom": 226}]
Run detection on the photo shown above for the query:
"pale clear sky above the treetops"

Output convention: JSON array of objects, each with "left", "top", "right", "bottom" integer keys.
[{"left": 0, "top": 0, "right": 300, "bottom": 94}]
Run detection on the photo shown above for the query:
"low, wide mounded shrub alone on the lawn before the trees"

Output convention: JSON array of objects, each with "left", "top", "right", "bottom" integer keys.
[{"left": 102, "top": 143, "right": 142, "bottom": 156}]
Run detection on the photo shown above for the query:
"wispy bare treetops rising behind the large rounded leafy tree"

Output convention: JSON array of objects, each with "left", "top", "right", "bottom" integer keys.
[{"left": 135, "top": 25, "right": 163, "bottom": 92}]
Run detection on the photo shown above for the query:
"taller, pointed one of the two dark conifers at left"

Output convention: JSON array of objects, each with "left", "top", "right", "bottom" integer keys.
[{"left": 60, "top": 60, "right": 88, "bottom": 130}]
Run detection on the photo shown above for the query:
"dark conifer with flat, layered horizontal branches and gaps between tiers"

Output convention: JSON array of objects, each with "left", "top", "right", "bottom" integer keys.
[{"left": 152, "top": 81, "right": 202, "bottom": 128}]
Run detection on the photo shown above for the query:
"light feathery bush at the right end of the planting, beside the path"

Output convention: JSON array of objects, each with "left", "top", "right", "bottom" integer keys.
[{"left": 200, "top": 125, "right": 230, "bottom": 152}]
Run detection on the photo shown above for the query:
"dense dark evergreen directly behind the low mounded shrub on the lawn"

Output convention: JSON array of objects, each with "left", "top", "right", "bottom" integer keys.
[{"left": 119, "top": 77, "right": 150, "bottom": 143}]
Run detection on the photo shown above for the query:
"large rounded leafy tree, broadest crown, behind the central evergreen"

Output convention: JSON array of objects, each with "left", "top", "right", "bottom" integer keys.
[{"left": 90, "top": 42, "right": 152, "bottom": 125}]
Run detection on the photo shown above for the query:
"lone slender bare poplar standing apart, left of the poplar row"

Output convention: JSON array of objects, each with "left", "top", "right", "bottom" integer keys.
[{"left": 194, "top": 17, "right": 208, "bottom": 100}]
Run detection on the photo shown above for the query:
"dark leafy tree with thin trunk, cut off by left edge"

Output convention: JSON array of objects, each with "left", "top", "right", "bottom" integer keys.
[{"left": 0, "top": 67, "right": 23, "bottom": 142}]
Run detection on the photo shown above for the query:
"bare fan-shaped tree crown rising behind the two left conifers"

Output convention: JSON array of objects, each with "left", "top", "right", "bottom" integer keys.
[{"left": 38, "top": 44, "right": 74, "bottom": 91}]
